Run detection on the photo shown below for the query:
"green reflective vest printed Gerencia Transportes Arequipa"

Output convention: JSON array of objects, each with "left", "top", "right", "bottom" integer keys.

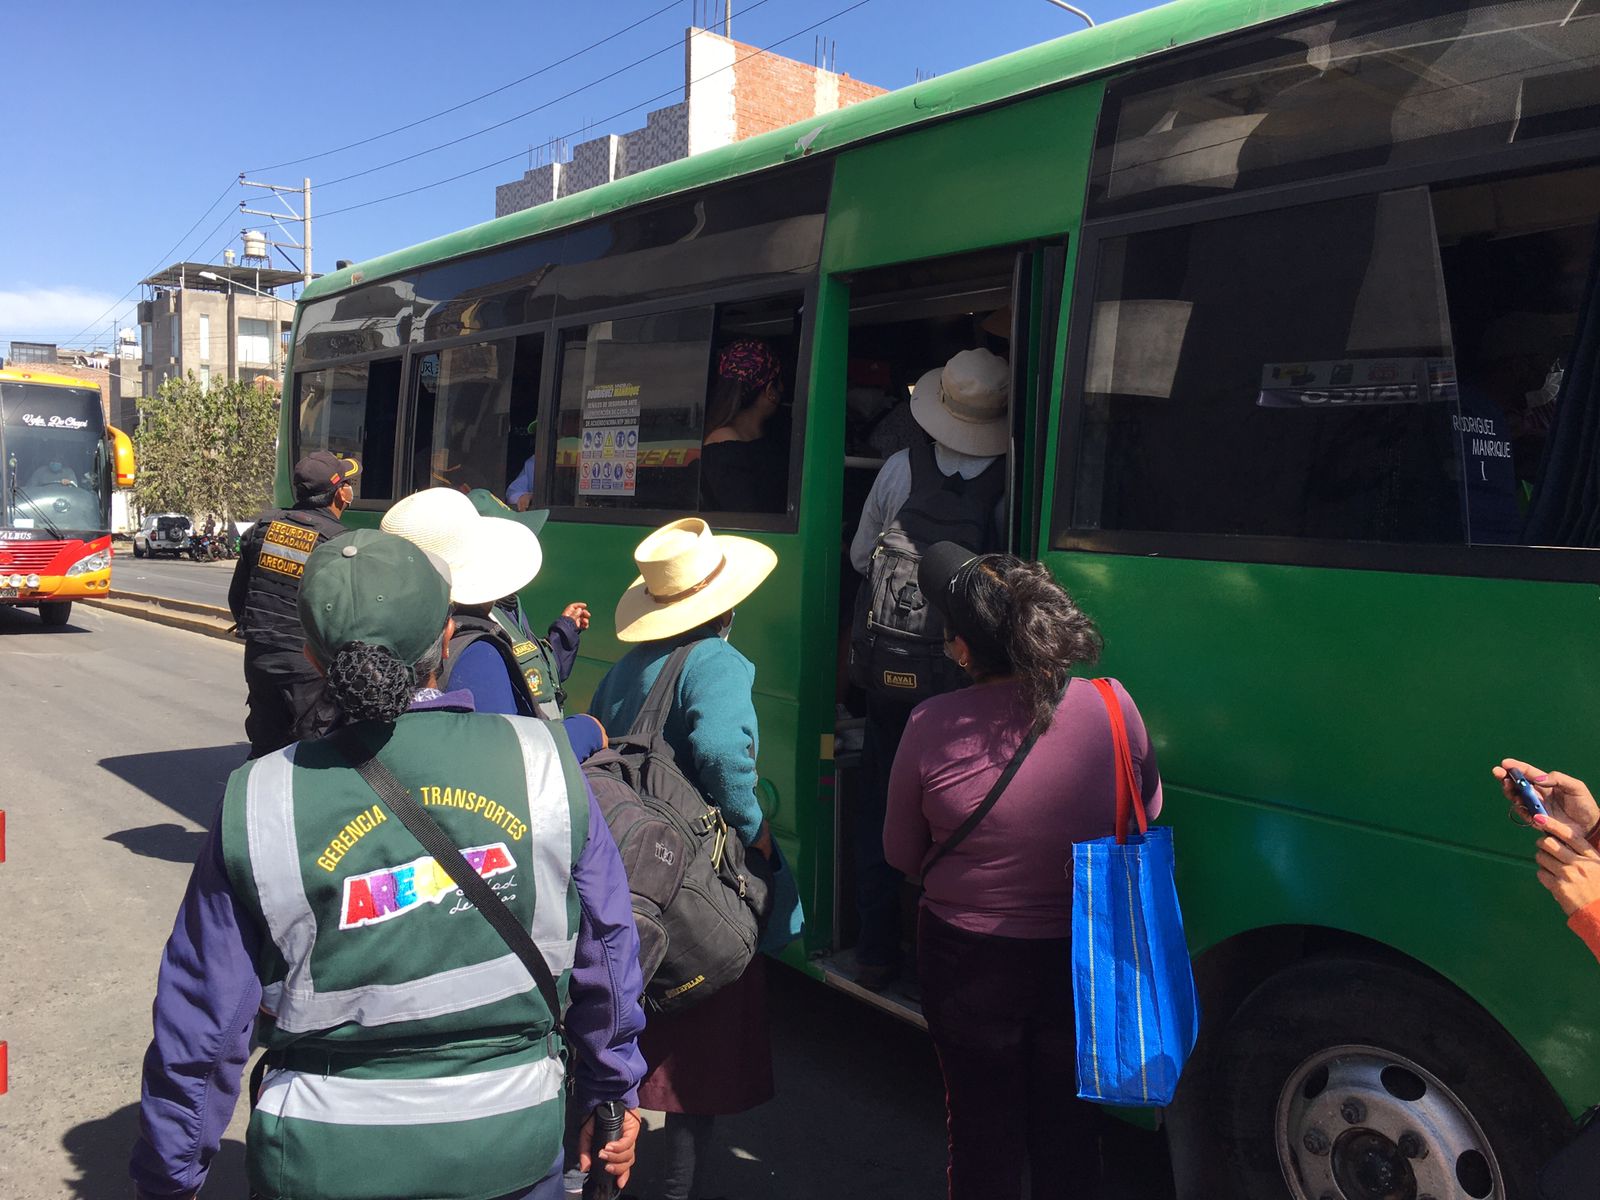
[{"left": 222, "top": 710, "right": 589, "bottom": 1200}]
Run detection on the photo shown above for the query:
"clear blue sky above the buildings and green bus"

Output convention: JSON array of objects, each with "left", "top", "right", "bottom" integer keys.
[{"left": 0, "top": 0, "right": 1152, "bottom": 346}]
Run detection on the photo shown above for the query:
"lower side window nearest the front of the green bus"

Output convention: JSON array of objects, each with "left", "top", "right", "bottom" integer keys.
[{"left": 294, "top": 358, "right": 400, "bottom": 501}]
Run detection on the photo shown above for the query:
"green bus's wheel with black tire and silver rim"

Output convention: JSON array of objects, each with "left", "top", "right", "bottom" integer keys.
[{"left": 1211, "top": 957, "right": 1573, "bottom": 1200}]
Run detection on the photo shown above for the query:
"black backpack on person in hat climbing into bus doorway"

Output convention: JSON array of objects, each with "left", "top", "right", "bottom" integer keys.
[{"left": 850, "top": 438, "right": 1006, "bottom": 706}]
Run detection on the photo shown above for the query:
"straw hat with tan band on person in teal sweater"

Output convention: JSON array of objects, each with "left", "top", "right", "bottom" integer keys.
[{"left": 616, "top": 517, "right": 778, "bottom": 642}]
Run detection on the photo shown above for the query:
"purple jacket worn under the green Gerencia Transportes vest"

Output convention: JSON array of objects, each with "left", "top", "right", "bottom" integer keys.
[{"left": 130, "top": 691, "right": 645, "bottom": 1197}]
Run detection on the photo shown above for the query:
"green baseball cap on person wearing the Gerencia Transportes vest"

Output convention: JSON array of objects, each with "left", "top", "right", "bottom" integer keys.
[{"left": 299, "top": 530, "right": 450, "bottom": 667}]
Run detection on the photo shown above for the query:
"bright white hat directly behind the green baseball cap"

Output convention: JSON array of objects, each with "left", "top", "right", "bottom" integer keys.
[{"left": 382, "top": 488, "right": 544, "bottom": 605}]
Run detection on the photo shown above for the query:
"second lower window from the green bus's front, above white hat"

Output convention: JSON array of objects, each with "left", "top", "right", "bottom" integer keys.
[{"left": 411, "top": 334, "right": 542, "bottom": 494}]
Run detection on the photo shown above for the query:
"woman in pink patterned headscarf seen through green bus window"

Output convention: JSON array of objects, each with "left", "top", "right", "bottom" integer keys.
[{"left": 701, "top": 338, "right": 789, "bottom": 512}]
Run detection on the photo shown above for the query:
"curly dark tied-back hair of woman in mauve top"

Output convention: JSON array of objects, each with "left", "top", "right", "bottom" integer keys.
[{"left": 944, "top": 554, "right": 1104, "bottom": 733}]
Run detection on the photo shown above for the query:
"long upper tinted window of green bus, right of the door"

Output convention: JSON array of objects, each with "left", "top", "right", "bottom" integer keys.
[{"left": 1090, "top": 0, "right": 1600, "bottom": 218}]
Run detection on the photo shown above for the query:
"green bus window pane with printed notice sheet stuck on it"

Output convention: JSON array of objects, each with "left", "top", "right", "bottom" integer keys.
[{"left": 552, "top": 306, "right": 715, "bottom": 512}]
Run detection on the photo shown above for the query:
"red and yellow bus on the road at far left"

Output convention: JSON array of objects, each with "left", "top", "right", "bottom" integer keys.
[{"left": 0, "top": 368, "right": 133, "bottom": 626}]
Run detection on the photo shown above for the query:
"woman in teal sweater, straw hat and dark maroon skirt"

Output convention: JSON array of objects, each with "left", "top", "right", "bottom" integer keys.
[{"left": 590, "top": 517, "right": 778, "bottom": 1200}]
